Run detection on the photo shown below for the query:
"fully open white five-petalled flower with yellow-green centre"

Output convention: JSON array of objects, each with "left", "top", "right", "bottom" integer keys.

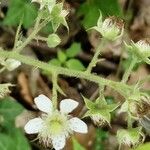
[{"left": 24, "top": 95, "right": 87, "bottom": 150}]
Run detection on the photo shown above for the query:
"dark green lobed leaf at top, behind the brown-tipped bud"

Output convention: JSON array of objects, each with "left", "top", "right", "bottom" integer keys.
[{"left": 77, "top": 0, "right": 122, "bottom": 29}]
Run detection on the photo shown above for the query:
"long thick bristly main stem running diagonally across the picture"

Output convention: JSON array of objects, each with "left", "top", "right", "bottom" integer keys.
[{"left": 0, "top": 49, "right": 132, "bottom": 96}]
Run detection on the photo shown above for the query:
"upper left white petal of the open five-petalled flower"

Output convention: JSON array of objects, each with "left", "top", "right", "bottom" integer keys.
[{"left": 34, "top": 94, "right": 53, "bottom": 113}]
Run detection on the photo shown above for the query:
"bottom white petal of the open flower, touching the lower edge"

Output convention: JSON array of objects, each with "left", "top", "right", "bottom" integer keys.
[{"left": 52, "top": 135, "right": 66, "bottom": 150}]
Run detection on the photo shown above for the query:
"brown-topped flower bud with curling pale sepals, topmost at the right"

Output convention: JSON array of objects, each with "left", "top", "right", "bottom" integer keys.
[{"left": 93, "top": 13, "right": 124, "bottom": 41}]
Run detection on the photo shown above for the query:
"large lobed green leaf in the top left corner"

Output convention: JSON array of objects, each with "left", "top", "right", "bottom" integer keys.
[{"left": 3, "top": 0, "right": 37, "bottom": 28}]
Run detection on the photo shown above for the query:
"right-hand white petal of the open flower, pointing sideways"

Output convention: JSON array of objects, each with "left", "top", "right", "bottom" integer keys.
[{"left": 69, "top": 117, "right": 88, "bottom": 133}]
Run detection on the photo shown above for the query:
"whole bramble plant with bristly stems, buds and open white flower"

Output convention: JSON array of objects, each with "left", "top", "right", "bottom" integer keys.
[{"left": 0, "top": 0, "right": 150, "bottom": 150}]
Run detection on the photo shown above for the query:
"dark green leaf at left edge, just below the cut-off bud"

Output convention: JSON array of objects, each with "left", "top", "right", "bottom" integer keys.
[{"left": 0, "top": 97, "right": 23, "bottom": 124}]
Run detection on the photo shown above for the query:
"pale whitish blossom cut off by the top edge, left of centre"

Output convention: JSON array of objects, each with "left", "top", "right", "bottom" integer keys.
[{"left": 31, "top": 0, "right": 56, "bottom": 12}]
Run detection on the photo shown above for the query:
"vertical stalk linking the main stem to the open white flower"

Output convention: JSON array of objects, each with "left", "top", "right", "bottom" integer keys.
[{"left": 52, "top": 72, "right": 57, "bottom": 109}]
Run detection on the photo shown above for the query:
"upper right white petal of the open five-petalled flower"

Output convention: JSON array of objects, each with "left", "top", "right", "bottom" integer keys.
[{"left": 60, "top": 99, "right": 79, "bottom": 114}]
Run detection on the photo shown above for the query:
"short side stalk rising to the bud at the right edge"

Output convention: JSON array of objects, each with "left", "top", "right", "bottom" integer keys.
[{"left": 121, "top": 58, "right": 137, "bottom": 83}]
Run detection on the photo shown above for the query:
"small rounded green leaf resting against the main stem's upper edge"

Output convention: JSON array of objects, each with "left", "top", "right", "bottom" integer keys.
[{"left": 66, "top": 59, "right": 85, "bottom": 70}]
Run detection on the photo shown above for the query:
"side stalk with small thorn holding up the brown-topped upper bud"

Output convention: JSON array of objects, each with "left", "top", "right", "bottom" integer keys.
[{"left": 86, "top": 39, "right": 106, "bottom": 73}]
